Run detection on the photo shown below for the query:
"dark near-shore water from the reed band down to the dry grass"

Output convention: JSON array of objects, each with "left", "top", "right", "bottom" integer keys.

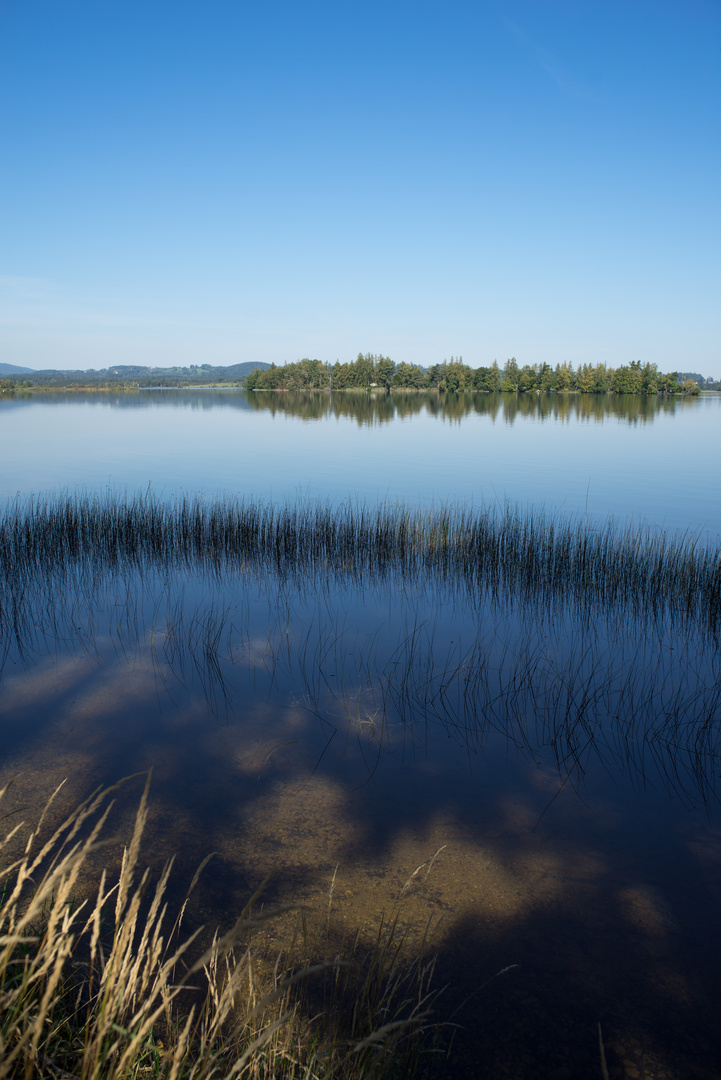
[{"left": 0, "top": 494, "right": 721, "bottom": 1080}]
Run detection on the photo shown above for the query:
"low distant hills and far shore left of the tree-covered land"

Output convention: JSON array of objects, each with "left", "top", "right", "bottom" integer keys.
[{"left": 12, "top": 361, "right": 270, "bottom": 387}]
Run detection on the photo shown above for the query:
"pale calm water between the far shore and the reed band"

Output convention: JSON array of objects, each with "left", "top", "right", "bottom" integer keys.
[{"left": 0, "top": 390, "right": 721, "bottom": 537}]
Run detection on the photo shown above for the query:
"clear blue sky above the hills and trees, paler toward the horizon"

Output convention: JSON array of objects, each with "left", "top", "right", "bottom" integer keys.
[{"left": 0, "top": 0, "right": 721, "bottom": 378}]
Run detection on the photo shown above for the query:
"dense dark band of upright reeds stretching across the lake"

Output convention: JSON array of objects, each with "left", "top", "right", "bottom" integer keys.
[{"left": 0, "top": 494, "right": 721, "bottom": 633}]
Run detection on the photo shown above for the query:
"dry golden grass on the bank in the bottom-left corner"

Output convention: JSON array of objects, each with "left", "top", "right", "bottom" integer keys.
[{"left": 0, "top": 781, "right": 442, "bottom": 1080}]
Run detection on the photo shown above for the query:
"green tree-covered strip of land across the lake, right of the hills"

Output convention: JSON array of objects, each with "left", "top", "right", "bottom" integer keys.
[{"left": 245, "top": 352, "right": 698, "bottom": 394}]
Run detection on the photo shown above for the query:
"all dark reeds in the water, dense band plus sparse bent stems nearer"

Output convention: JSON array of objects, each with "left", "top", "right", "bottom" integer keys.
[{"left": 0, "top": 495, "right": 721, "bottom": 800}]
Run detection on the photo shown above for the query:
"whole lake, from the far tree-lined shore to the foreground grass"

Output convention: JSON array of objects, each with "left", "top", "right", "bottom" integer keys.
[{"left": 0, "top": 390, "right": 721, "bottom": 1080}]
